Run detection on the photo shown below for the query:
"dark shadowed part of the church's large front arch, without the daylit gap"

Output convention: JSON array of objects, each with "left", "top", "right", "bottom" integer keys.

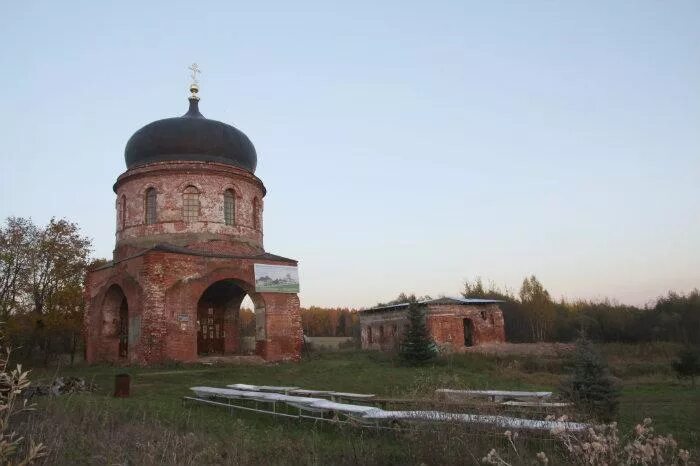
[{"left": 197, "top": 280, "right": 246, "bottom": 355}]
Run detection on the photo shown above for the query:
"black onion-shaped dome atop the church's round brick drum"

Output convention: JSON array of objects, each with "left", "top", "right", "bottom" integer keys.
[{"left": 124, "top": 98, "right": 258, "bottom": 173}]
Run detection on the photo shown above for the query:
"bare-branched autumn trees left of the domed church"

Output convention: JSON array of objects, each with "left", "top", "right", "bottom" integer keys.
[{"left": 0, "top": 217, "right": 91, "bottom": 361}]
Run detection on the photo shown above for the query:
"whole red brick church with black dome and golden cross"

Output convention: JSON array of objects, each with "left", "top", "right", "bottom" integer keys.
[{"left": 85, "top": 75, "right": 302, "bottom": 364}]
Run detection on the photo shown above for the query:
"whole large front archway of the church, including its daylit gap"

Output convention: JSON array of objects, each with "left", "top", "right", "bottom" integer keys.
[{"left": 197, "top": 280, "right": 265, "bottom": 356}]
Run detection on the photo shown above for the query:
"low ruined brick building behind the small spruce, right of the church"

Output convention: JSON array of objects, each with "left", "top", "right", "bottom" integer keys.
[{"left": 360, "top": 298, "right": 506, "bottom": 351}]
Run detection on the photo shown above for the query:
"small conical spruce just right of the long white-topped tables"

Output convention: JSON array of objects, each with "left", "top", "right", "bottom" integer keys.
[{"left": 561, "top": 336, "right": 620, "bottom": 421}]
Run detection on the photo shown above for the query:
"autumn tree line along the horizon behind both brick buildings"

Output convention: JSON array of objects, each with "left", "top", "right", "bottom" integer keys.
[{"left": 0, "top": 217, "right": 700, "bottom": 361}]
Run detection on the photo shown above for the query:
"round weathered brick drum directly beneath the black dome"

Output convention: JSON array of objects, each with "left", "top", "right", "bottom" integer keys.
[{"left": 115, "top": 162, "right": 265, "bottom": 258}]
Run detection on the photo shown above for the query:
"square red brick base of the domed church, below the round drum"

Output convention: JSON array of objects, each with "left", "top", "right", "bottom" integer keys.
[{"left": 85, "top": 251, "right": 302, "bottom": 364}]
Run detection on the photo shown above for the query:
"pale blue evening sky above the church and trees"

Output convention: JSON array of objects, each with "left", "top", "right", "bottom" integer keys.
[{"left": 0, "top": 0, "right": 700, "bottom": 307}]
